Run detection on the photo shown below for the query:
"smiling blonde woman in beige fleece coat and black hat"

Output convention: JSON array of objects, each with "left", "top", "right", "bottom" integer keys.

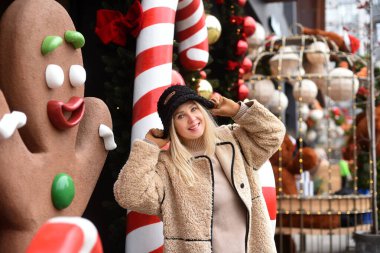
[{"left": 114, "top": 85, "right": 285, "bottom": 253}]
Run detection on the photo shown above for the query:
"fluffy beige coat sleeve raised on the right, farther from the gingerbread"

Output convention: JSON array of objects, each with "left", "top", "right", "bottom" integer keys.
[{"left": 229, "top": 100, "right": 285, "bottom": 169}]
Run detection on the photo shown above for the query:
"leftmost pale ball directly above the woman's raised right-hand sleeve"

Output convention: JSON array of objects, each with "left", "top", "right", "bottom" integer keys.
[{"left": 248, "top": 79, "right": 275, "bottom": 105}]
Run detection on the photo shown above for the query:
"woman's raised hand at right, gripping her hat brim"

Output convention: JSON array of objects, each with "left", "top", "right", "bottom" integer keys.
[{"left": 210, "top": 94, "right": 240, "bottom": 117}]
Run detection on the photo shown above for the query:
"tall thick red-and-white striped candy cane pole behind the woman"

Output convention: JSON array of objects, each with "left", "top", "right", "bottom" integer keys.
[{"left": 126, "top": 0, "right": 178, "bottom": 253}]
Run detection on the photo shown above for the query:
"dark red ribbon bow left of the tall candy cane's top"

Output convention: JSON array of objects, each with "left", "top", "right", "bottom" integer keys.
[{"left": 95, "top": 0, "right": 143, "bottom": 46}]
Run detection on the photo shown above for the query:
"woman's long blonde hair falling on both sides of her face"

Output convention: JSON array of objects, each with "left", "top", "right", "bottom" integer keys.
[{"left": 169, "top": 101, "right": 217, "bottom": 186}]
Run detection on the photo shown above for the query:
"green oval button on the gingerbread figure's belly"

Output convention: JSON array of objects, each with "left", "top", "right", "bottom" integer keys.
[{"left": 51, "top": 173, "right": 75, "bottom": 210}]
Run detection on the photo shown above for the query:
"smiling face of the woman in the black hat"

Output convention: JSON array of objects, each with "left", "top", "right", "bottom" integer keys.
[{"left": 173, "top": 101, "right": 205, "bottom": 140}]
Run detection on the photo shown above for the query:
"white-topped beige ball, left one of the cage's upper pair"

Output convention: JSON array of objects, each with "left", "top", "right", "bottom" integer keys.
[{"left": 269, "top": 47, "right": 301, "bottom": 76}]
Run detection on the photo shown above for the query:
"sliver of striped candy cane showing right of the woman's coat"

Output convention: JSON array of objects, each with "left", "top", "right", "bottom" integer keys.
[{"left": 259, "top": 161, "right": 277, "bottom": 236}]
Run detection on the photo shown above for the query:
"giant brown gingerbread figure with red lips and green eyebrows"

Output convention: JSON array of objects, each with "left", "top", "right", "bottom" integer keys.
[{"left": 0, "top": 0, "right": 116, "bottom": 253}]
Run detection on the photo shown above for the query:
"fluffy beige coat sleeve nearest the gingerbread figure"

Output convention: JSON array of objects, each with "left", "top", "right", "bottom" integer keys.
[{"left": 113, "top": 140, "right": 164, "bottom": 216}]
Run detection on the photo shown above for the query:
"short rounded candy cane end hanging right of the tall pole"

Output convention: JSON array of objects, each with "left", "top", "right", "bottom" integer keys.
[{"left": 175, "top": 0, "right": 209, "bottom": 70}]
